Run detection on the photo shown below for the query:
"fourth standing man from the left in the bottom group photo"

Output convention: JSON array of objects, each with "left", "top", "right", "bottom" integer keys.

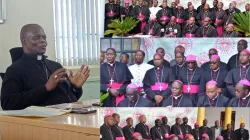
[{"left": 135, "top": 115, "right": 151, "bottom": 139}]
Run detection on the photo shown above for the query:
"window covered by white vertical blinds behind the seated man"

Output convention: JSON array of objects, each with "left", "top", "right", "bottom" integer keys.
[{"left": 53, "top": 0, "right": 104, "bottom": 66}]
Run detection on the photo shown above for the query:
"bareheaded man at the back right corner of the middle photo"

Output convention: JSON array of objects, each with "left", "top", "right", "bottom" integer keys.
[{"left": 227, "top": 39, "right": 248, "bottom": 70}]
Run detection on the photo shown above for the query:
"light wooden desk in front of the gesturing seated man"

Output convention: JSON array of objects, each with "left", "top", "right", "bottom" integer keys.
[{"left": 0, "top": 100, "right": 100, "bottom": 140}]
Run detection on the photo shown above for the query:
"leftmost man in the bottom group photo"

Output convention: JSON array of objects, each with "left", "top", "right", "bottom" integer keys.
[{"left": 100, "top": 115, "right": 115, "bottom": 140}]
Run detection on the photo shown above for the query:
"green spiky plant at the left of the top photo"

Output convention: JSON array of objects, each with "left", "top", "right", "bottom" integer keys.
[{"left": 105, "top": 17, "right": 139, "bottom": 37}]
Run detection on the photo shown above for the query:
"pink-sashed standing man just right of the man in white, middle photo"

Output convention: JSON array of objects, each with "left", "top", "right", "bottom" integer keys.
[{"left": 143, "top": 54, "right": 174, "bottom": 106}]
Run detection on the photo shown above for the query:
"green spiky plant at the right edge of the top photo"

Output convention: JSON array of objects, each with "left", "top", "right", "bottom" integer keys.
[{"left": 233, "top": 12, "right": 250, "bottom": 37}]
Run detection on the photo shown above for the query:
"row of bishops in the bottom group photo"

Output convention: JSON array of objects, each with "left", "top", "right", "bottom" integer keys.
[{"left": 100, "top": 113, "right": 249, "bottom": 140}]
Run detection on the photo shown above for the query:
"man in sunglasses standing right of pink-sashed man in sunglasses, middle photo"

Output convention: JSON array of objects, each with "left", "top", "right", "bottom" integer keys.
[{"left": 199, "top": 54, "right": 229, "bottom": 97}]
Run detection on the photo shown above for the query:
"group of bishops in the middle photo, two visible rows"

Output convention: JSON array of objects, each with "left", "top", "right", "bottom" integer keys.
[{"left": 100, "top": 39, "right": 250, "bottom": 107}]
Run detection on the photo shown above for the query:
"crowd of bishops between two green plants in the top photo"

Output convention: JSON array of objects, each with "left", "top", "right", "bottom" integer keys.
[{"left": 105, "top": 0, "right": 250, "bottom": 37}]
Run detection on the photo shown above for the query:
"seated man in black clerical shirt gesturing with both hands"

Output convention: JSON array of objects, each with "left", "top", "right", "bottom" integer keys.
[{"left": 1, "top": 24, "right": 89, "bottom": 110}]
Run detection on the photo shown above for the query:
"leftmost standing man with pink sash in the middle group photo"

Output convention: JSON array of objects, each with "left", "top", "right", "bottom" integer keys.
[{"left": 100, "top": 48, "right": 133, "bottom": 107}]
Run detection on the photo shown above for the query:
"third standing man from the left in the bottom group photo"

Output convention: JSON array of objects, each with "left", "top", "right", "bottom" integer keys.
[{"left": 122, "top": 117, "right": 135, "bottom": 140}]
